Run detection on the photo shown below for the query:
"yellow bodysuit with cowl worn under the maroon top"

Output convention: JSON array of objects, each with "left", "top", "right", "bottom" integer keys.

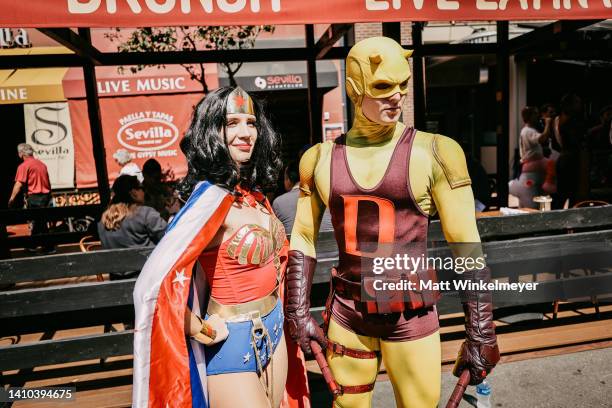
[{"left": 290, "top": 37, "right": 492, "bottom": 408}]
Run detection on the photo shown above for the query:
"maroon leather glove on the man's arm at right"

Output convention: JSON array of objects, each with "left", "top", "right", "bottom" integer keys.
[{"left": 453, "top": 268, "right": 499, "bottom": 385}]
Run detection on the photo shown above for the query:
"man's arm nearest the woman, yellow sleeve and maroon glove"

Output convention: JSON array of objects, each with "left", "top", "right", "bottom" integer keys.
[{"left": 285, "top": 145, "right": 327, "bottom": 355}]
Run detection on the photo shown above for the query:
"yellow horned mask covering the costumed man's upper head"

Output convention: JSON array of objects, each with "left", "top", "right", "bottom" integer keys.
[{"left": 346, "top": 37, "right": 412, "bottom": 105}]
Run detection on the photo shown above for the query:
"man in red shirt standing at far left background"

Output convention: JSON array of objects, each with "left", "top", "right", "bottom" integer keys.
[{"left": 8, "top": 143, "right": 54, "bottom": 252}]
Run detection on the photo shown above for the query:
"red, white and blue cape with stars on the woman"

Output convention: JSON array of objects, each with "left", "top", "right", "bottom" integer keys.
[{"left": 132, "top": 182, "right": 233, "bottom": 408}]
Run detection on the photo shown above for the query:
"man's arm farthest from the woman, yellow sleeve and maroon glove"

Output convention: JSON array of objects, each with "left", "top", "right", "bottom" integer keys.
[{"left": 432, "top": 136, "right": 499, "bottom": 385}]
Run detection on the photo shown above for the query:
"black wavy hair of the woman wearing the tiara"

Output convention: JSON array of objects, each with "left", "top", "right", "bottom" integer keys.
[{"left": 179, "top": 87, "right": 282, "bottom": 198}]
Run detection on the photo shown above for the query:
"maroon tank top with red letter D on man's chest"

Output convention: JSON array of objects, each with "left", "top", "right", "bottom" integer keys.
[{"left": 329, "top": 128, "right": 428, "bottom": 281}]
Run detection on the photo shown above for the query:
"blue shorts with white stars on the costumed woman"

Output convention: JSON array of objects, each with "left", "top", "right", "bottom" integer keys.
[{"left": 205, "top": 300, "right": 284, "bottom": 375}]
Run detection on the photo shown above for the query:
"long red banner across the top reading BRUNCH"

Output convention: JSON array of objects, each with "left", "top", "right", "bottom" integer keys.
[{"left": 0, "top": 0, "right": 612, "bottom": 27}]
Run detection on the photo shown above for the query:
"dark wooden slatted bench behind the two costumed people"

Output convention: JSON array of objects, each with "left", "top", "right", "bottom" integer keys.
[{"left": 0, "top": 206, "right": 612, "bottom": 381}]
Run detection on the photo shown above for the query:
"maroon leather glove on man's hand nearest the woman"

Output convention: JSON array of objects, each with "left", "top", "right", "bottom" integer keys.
[{"left": 285, "top": 250, "right": 327, "bottom": 357}]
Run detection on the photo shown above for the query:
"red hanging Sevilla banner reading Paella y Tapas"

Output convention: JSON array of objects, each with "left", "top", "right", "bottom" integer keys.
[{"left": 68, "top": 94, "right": 202, "bottom": 188}]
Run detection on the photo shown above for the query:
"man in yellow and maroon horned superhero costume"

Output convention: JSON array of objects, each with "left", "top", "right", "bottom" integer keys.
[{"left": 286, "top": 37, "right": 499, "bottom": 407}]
